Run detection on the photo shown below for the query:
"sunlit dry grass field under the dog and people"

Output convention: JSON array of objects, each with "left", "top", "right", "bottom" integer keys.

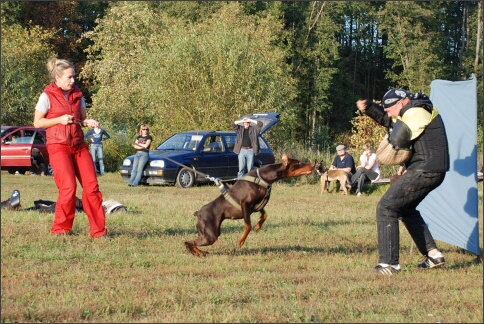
[{"left": 1, "top": 172, "right": 483, "bottom": 323}]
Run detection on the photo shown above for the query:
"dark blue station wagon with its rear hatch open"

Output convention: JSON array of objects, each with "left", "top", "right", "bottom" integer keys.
[{"left": 119, "top": 113, "right": 280, "bottom": 188}]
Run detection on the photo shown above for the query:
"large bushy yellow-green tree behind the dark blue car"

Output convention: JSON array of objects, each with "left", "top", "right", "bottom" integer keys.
[{"left": 83, "top": 2, "right": 294, "bottom": 140}]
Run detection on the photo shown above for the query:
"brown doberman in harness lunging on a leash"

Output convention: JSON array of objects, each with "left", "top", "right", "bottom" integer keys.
[{"left": 185, "top": 154, "right": 316, "bottom": 256}]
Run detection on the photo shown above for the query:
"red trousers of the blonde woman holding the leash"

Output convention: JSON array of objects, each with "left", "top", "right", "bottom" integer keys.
[{"left": 47, "top": 144, "right": 108, "bottom": 238}]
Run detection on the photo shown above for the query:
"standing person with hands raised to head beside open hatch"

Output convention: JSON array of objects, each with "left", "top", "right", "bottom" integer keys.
[{"left": 232, "top": 117, "right": 264, "bottom": 178}]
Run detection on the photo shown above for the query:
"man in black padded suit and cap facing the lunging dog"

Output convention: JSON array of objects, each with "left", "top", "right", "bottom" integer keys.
[{"left": 356, "top": 89, "right": 449, "bottom": 275}]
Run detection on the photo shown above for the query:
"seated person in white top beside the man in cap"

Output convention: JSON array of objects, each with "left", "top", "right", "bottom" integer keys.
[{"left": 351, "top": 144, "right": 380, "bottom": 197}]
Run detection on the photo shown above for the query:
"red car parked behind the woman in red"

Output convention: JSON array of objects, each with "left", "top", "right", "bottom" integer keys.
[{"left": 1, "top": 126, "right": 52, "bottom": 174}]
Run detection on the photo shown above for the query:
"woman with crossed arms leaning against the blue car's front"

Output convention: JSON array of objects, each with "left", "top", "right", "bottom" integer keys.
[{"left": 128, "top": 124, "right": 153, "bottom": 187}]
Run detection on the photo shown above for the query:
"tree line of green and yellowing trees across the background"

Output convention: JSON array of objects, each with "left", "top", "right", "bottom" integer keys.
[{"left": 0, "top": 1, "right": 483, "bottom": 156}]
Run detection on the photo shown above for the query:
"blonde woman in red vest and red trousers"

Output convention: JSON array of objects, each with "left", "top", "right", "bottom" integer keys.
[{"left": 34, "top": 58, "right": 108, "bottom": 238}]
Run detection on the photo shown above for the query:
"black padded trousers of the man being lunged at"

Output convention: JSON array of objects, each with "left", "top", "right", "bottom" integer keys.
[{"left": 376, "top": 170, "right": 445, "bottom": 265}]
